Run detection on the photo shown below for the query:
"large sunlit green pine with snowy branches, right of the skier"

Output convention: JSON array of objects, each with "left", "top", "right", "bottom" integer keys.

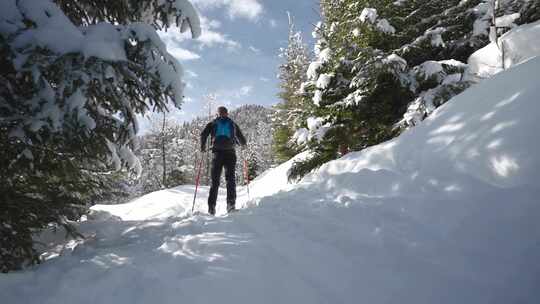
[{"left": 289, "top": 0, "right": 408, "bottom": 179}]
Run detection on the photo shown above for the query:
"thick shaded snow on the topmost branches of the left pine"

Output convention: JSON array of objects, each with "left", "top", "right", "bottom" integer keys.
[{"left": 0, "top": 0, "right": 201, "bottom": 61}]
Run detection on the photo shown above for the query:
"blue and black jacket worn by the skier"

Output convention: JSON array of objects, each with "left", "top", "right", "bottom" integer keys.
[{"left": 201, "top": 117, "right": 247, "bottom": 152}]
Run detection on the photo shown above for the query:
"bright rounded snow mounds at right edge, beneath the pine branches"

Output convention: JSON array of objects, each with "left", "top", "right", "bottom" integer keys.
[{"left": 468, "top": 21, "right": 540, "bottom": 78}]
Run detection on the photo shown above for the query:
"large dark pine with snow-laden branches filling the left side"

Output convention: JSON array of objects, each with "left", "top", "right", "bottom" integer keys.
[{"left": 0, "top": 0, "right": 200, "bottom": 272}]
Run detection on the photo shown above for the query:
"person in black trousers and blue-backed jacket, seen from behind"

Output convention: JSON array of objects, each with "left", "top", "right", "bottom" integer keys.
[{"left": 201, "top": 106, "right": 247, "bottom": 215}]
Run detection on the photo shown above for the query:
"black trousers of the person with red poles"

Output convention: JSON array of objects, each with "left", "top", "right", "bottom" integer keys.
[{"left": 208, "top": 150, "right": 236, "bottom": 207}]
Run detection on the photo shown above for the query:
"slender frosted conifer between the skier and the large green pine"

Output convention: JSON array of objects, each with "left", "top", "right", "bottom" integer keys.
[{"left": 272, "top": 13, "right": 311, "bottom": 162}]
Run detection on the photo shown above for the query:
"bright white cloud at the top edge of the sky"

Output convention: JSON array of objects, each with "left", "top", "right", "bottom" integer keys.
[{"left": 191, "top": 0, "right": 264, "bottom": 21}]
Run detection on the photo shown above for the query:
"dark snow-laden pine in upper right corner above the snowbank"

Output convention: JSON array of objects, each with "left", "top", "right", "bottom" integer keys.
[{"left": 394, "top": 0, "right": 540, "bottom": 128}]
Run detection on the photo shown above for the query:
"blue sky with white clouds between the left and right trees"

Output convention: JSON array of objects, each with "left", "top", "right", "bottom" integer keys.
[{"left": 142, "top": 0, "right": 320, "bottom": 128}]
